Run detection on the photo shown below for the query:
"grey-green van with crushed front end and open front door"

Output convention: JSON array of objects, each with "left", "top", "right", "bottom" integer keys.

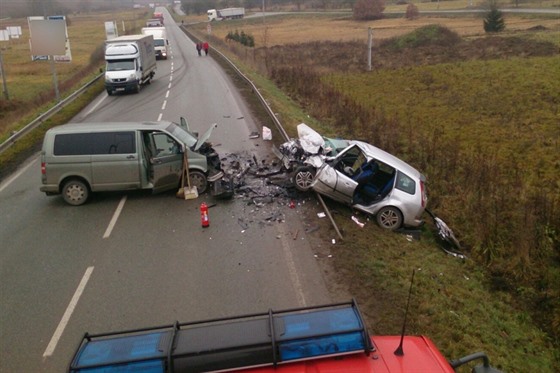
[{"left": 40, "top": 118, "right": 221, "bottom": 206}]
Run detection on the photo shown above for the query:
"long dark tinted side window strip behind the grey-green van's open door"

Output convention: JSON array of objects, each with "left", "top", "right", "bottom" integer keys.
[{"left": 53, "top": 132, "right": 136, "bottom": 155}]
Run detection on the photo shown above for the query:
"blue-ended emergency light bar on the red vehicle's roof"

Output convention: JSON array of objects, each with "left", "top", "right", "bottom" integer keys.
[{"left": 69, "top": 300, "right": 373, "bottom": 373}]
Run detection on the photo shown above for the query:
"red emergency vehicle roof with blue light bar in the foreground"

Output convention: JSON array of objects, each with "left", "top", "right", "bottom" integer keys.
[{"left": 68, "top": 300, "right": 499, "bottom": 373}]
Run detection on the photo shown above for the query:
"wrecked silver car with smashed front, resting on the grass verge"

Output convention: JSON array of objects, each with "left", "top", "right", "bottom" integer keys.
[{"left": 280, "top": 125, "right": 427, "bottom": 230}]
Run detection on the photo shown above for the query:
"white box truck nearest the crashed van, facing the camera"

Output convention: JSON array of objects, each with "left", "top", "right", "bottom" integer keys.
[{"left": 105, "top": 35, "right": 156, "bottom": 95}]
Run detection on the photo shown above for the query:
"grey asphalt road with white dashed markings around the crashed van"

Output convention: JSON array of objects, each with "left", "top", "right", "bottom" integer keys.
[{"left": 0, "top": 9, "right": 331, "bottom": 373}]
